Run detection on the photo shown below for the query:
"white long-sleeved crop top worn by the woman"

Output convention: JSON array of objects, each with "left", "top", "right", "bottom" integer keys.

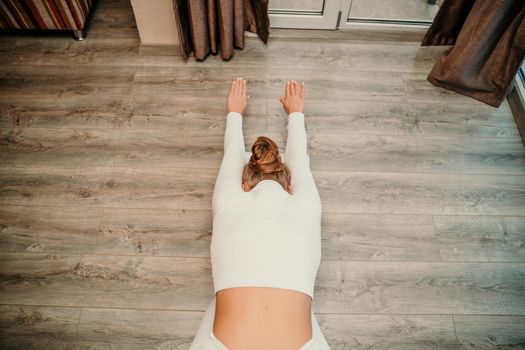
[{"left": 210, "top": 112, "right": 322, "bottom": 299}]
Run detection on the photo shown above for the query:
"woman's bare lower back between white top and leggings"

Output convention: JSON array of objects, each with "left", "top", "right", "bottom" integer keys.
[{"left": 213, "top": 287, "right": 312, "bottom": 350}]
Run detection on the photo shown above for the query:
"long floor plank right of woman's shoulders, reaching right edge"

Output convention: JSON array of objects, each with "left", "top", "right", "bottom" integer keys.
[{"left": 313, "top": 171, "right": 525, "bottom": 216}]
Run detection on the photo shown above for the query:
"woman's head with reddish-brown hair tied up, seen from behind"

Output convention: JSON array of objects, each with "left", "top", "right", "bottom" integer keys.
[{"left": 242, "top": 136, "right": 292, "bottom": 193}]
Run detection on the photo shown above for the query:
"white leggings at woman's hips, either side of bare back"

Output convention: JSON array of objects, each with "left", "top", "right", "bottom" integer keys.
[{"left": 190, "top": 296, "right": 330, "bottom": 350}]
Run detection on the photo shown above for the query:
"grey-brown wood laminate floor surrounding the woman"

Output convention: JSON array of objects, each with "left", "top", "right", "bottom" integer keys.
[{"left": 0, "top": 0, "right": 525, "bottom": 350}]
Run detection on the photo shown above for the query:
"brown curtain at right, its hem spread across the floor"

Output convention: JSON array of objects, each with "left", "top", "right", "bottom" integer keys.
[{"left": 421, "top": 0, "right": 525, "bottom": 107}]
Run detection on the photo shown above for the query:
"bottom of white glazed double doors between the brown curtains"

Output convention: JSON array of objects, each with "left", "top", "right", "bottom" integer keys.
[{"left": 269, "top": 0, "right": 441, "bottom": 29}]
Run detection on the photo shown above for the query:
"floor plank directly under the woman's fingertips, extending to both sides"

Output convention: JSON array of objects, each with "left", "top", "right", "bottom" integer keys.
[{"left": 134, "top": 66, "right": 405, "bottom": 101}]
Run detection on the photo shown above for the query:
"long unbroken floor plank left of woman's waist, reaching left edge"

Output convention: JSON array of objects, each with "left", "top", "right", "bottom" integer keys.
[{"left": 0, "top": 252, "right": 213, "bottom": 310}]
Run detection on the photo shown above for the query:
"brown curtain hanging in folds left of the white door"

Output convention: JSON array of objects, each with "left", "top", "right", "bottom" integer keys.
[{"left": 173, "top": 0, "right": 270, "bottom": 61}]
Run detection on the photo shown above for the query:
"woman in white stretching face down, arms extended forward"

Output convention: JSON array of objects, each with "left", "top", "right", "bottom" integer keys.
[{"left": 190, "top": 78, "right": 330, "bottom": 350}]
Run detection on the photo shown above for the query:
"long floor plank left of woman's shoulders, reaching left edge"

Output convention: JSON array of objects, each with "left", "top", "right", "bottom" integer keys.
[{"left": 0, "top": 166, "right": 218, "bottom": 210}]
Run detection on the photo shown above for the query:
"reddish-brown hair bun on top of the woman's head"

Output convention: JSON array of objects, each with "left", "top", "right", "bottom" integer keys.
[{"left": 248, "top": 136, "right": 285, "bottom": 174}]
